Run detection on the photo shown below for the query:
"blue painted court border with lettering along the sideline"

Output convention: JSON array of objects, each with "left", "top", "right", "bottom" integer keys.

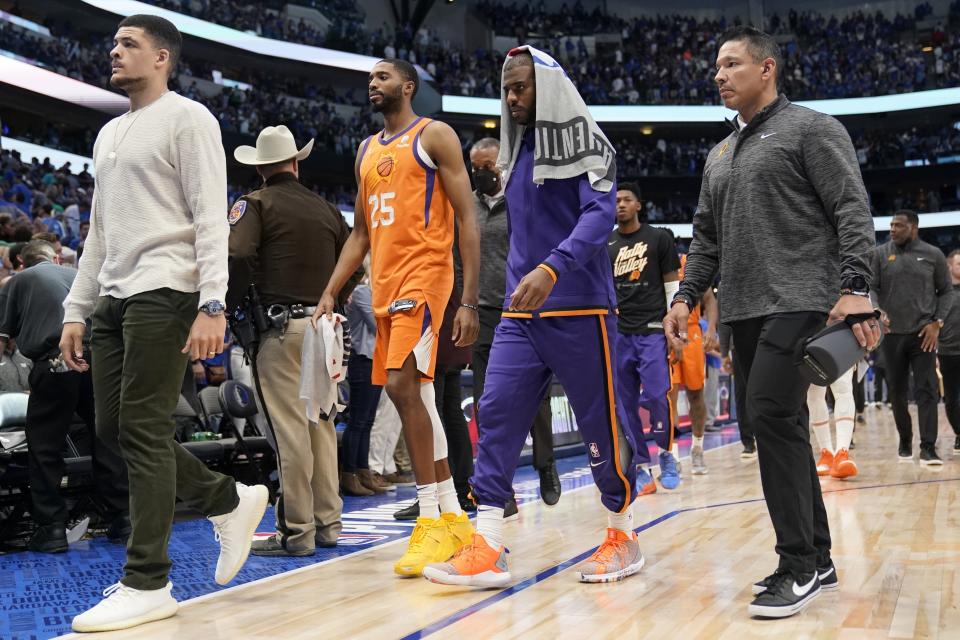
[{"left": 0, "top": 425, "right": 738, "bottom": 640}]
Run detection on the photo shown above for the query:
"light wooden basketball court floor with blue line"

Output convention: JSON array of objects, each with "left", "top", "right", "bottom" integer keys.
[{"left": 58, "top": 408, "right": 960, "bottom": 640}]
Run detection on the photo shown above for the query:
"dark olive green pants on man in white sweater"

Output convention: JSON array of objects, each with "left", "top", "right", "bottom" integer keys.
[{"left": 91, "top": 289, "right": 239, "bottom": 589}]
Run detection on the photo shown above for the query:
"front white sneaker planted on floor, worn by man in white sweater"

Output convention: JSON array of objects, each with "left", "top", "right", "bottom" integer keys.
[{"left": 71, "top": 582, "right": 180, "bottom": 633}]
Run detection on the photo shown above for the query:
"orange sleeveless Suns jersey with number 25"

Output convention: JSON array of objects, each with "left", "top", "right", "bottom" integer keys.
[{"left": 358, "top": 118, "right": 453, "bottom": 328}]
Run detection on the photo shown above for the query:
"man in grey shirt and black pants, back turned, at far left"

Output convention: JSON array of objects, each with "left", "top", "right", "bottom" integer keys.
[{"left": 0, "top": 240, "right": 130, "bottom": 553}]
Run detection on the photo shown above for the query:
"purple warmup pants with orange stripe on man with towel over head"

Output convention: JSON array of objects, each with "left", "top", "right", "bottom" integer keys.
[{"left": 470, "top": 314, "right": 637, "bottom": 512}]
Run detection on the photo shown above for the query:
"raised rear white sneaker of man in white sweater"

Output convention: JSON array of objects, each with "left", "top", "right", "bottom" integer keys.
[{"left": 207, "top": 482, "right": 269, "bottom": 584}]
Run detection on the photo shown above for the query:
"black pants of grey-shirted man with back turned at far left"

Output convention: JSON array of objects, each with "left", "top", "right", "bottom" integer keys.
[{"left": 26, "top": 359, "right": 130, "bottom": 526}]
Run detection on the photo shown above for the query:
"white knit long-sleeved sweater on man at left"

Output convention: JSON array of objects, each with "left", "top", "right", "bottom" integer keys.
[{"left": 63, "top": 92, "right": 230, "bottom": 322}]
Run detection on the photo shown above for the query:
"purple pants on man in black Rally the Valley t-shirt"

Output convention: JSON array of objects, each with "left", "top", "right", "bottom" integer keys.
[{"left": 617, "top": 333, "right": 673, "bottom": 464}]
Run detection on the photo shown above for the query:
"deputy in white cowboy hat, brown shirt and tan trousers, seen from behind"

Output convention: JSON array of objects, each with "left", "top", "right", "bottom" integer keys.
[{"left": 226, "top": 125, "right": 362, "bottom": 556}]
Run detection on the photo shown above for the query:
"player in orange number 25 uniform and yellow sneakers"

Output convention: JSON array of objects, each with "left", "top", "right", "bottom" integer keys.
[{"left": 313, "top": 59, "right": 480, "bottom": 576}]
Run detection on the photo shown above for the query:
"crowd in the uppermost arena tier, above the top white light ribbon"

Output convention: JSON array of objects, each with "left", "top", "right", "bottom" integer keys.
[{"left": 135, "top": 0, "right": 960, "bottom": 104}]
